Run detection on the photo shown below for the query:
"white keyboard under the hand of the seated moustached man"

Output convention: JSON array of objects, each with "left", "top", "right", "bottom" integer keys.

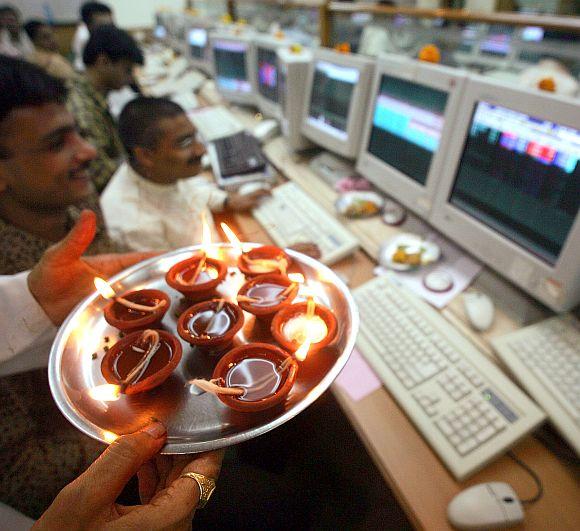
[{"left": 253, "top": 182, "right": 358, "bottom": 265}]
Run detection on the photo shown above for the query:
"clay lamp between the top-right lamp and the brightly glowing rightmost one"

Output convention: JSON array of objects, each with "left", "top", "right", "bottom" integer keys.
[{"left": 237, "top": 274, "right": 298, "bottom": 321}]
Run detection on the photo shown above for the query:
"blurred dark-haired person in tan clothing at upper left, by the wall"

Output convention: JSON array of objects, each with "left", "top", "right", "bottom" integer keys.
[{"left": 24, "top": 20, "right": 75, "bottom": 80}]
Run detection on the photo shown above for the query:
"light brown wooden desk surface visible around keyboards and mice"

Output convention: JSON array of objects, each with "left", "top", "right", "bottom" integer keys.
[{"left": 181, "top": 78, "right": 580, "bottom": 530}]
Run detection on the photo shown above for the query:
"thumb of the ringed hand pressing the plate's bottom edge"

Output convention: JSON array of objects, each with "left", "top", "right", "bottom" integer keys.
[{"left": 75, "top": 422, "right": 167, "bottom": 505}]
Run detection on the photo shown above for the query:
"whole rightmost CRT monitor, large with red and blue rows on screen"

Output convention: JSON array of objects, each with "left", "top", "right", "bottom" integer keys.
[{"left": 431, "top": 77, "right": 580, "bottom": 311}]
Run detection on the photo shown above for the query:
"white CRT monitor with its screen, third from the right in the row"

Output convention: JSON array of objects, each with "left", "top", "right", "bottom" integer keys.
[{"left": 302, "top": 49, "right": 374, "bottom": 159}]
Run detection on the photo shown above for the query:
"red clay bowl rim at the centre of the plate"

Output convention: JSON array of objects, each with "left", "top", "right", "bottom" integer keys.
[{"left": 177, "top": 299, "right": 244, "bottom": 352}]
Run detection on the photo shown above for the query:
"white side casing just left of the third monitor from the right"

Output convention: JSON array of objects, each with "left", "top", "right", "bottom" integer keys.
[{"left": 278, "top": 48, "right": 314, "bottom": 151}]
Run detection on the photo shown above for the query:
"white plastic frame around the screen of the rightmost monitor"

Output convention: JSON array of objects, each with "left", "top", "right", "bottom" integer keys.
[{"left": 430, "top": 76, "right": 580, "bottom": 312}]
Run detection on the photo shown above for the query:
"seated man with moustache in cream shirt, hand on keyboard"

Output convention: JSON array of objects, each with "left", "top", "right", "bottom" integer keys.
[{"left": 101, "top": 97, "right": 266, "bottom": 250}]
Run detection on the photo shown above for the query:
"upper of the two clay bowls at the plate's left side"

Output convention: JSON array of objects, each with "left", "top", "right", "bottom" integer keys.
[{"left": 104, "top": 289, "right": 171, "bottom": 332}]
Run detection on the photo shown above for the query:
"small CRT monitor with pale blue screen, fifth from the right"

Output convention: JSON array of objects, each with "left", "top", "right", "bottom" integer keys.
[{"left": 210, "top": 32, "right": 255, "bottom": 104}]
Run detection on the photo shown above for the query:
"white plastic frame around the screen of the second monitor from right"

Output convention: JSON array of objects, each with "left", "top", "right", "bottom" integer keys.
[{"left": 356, "top": 55, "right": 467, "bottom": 218}]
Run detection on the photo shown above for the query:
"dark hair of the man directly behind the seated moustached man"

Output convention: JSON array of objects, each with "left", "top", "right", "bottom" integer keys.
[{"left": 83, "top": 25, "right": 145, "bottom": 66}]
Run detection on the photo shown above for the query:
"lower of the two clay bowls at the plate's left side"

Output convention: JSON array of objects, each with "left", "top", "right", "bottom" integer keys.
[{"left": 101, "top": 330, "right": 182, "bottom": 395}]
